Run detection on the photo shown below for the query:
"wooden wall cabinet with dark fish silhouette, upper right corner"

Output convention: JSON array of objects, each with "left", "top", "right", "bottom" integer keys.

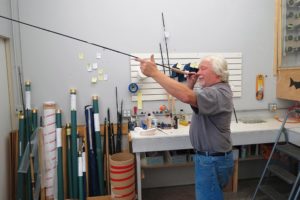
[{"left": 274, "top": 0, "right": 300, "bottom": 101}]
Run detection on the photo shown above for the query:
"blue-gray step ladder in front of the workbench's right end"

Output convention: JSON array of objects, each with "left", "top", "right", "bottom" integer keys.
[{"left": 252, "top": 109, "right": 300, "bottom": 200}]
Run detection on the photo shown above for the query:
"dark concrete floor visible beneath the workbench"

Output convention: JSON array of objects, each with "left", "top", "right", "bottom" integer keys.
[{"left": 142, "top": 179, "right": 269, "bottom": 200}]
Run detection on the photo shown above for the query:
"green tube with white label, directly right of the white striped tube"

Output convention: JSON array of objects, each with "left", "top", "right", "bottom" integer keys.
[{"left": 55, "top": 109, "right": 64, "bottom": 200}]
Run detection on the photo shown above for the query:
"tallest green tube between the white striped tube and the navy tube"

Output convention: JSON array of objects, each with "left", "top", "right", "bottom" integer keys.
[{"left": 70, "top": 88, "right": 78, "bottom": 198}]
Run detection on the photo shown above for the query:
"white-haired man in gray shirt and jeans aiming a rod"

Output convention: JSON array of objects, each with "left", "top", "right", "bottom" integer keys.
[{"left": 137, "top": 55, "right": 233, "bottom": 200}]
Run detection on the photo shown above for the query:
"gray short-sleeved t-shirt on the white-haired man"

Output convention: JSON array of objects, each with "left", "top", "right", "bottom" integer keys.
[{"left": 190, "top": 83, "right": 233, "bottom": 152}]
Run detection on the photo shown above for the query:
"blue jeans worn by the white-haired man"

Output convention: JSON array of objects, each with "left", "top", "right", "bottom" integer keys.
[{"left": 195, "top": 153, "right": 234, "bottom": 200}]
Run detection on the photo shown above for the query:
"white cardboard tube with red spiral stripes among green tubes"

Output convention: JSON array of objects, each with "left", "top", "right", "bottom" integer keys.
[{"left": 43, "top": 102, "right": 56, "bottom": 198}]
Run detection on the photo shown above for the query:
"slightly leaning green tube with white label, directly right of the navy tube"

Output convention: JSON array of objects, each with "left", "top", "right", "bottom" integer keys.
[{"left": 93, "top": 96, "right": 105, "bottom": 195}]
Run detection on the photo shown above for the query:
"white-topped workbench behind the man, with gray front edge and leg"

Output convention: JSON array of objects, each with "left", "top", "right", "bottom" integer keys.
[{"left": 130, "top": 118, "right": 300, "bottom": 200}]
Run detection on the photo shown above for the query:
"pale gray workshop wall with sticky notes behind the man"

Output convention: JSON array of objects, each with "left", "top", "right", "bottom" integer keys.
[{"left": 7, "top": 0, "right": 288, "bottom": 124}]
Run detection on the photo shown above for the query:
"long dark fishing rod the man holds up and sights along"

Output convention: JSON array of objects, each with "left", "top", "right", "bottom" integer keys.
[{"left": 0, "top": 15, "right": 189, "bottom": 75}]
